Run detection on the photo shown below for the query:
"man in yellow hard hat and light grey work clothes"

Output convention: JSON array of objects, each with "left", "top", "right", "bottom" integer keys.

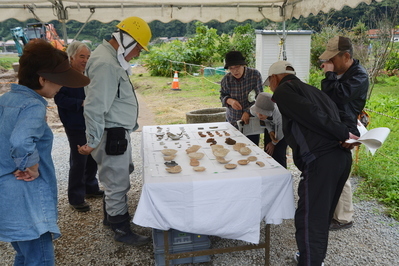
[{"left": 79, "top": 17, "right": 151, "bottom": 246}]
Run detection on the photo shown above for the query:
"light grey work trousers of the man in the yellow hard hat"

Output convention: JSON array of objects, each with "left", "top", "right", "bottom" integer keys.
[{"left": 91, "top": 131, "right": 134, "bottom": 216}]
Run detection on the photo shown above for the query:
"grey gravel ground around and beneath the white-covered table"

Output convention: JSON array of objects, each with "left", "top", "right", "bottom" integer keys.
[{"left": 0, "top": 132, "right": 399, "bottom": 266}]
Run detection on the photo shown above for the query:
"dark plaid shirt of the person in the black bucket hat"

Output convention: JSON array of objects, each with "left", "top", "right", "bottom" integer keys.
[{"left": 220, "top": 67, "right": 263, "bottom": 127}]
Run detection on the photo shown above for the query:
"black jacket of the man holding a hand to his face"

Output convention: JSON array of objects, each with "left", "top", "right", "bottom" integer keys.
[{"left": 321, "top": 59, "right": 369, "bottom": 136}]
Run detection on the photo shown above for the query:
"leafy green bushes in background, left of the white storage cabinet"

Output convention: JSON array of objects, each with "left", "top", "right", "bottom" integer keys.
[{"left": 140, "top": 22, "right": 255, "bottom": 77}]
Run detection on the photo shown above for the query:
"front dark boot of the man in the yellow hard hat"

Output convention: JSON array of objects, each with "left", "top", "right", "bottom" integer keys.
[{"left": 108, "top": 213, "right": 151, "bottom": 246}]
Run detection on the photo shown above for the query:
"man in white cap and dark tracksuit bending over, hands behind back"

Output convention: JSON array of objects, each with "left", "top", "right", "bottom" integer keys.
[{"left": 266, "top": 61, "right": 357, "bottom": 265}]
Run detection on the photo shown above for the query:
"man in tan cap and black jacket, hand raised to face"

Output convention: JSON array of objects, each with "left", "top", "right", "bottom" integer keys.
[{"left": 319, "top": 36, "right": 369, "bottom": 230}]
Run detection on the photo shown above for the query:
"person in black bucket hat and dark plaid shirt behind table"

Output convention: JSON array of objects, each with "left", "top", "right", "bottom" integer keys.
[{"left": 220, "top": 51, "right": 263, "bottom": 145}]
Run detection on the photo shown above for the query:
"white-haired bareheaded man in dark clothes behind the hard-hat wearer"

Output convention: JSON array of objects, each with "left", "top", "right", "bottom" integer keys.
[{"left": 54, "top": 41, "right": 104, "bottom": 212}]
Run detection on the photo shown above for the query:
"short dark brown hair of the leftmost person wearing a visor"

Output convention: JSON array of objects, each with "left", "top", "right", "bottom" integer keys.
[{"left": 18, "top": 39, "right": 68, "bottom": 90}]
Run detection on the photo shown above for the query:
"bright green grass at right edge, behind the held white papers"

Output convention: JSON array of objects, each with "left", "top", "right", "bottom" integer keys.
[{"left": 355, "top": 77, "right": 399, "bottom": 220}]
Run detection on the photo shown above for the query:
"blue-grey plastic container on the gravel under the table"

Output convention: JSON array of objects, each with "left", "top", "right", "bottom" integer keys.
[{"left": 152, "top": 229, "right": 211, "bottom": 266}]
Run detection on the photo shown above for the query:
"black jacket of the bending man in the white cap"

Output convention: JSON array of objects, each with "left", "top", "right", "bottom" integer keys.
[{"left": 272, "top": 75, "right": 350, "bottom": 171}]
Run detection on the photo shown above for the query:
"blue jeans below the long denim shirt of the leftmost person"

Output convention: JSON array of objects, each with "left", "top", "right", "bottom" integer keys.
[{"left": 11, "top": 232, "right": 55, "bottom": 266}]
